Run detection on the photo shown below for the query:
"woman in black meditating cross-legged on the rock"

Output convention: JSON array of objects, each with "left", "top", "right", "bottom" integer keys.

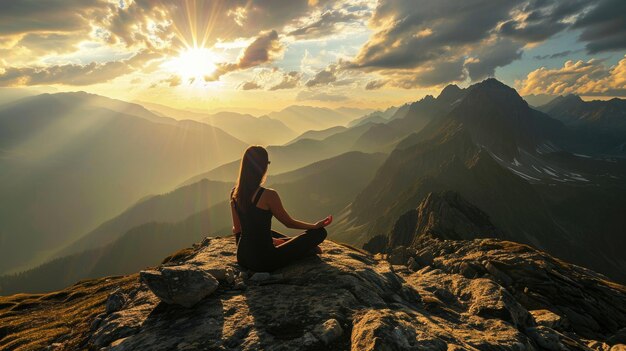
[{"left": 230, "top": 146, "right": 332, "bottom": 272}]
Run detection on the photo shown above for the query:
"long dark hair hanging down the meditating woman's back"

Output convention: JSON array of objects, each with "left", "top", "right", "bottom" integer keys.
[{"left": 233, "top": 146, "right": 269, "bottom": 212}]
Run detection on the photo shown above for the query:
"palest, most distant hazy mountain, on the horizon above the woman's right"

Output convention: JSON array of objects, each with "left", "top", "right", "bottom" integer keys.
[{"left": 268, "top": 106, "right": 364, "bottom": 133}]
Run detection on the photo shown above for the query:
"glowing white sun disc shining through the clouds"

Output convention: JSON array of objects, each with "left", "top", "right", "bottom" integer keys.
[{"left": 166, "top": 48, "right": 219, "bottom": 81}]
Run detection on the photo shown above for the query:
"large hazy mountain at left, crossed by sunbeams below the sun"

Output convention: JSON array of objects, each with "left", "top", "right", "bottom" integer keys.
[{"left": 0, "top": 93, "right": 246, "bottom": 272}]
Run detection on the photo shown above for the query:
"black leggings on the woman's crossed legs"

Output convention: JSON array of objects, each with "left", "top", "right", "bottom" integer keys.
[{"left": 237, "top": 228, "right": 327, "bottom": 271}]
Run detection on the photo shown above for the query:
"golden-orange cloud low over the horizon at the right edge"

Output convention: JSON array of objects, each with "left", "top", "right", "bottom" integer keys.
[{"left": 516, "top": 56, "right": 626, "bottom": 97}]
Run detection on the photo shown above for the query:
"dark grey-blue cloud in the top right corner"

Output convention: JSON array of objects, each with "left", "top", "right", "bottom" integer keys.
[{"left": 574, "top": 0, "right": 626, "bottom": 54}]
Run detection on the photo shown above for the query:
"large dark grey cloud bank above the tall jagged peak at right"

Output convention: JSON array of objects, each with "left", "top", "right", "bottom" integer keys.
[{"left": 341, "top": 0, "right": 626, "bottom": 88}]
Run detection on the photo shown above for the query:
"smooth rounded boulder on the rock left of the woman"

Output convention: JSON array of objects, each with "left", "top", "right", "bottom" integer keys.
[{"left": 139, "top": 265, "right": 219, "bottom": 307}]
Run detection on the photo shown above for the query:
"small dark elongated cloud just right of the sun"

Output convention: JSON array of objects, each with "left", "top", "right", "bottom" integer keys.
[{"left": 205, "top": 30, "right": 284, "bottom": 81}]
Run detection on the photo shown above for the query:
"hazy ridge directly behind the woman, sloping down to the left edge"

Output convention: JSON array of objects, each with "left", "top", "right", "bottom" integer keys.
[{"left": 0, "top": 152, "right": 385, "bottom": 295}]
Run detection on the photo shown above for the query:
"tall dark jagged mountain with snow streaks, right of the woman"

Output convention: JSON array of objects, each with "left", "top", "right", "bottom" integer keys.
[{"left": 335, "top": 80, "right": 626, "bottom": 281}]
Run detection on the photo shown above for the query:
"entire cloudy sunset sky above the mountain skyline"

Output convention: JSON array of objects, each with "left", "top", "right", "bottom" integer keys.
[{"left": 0, "top": 0, "right": 626, "bottom": 113}]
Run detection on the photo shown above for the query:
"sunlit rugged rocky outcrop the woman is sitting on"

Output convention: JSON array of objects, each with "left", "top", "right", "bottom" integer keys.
[{"left": 83, "top": 236, "right": 626, "bottom": 350}]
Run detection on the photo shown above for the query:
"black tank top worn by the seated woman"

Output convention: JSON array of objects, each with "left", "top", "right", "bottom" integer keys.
[{"left": 231, "top": 187, "right": 274, "bottom": 254}]
